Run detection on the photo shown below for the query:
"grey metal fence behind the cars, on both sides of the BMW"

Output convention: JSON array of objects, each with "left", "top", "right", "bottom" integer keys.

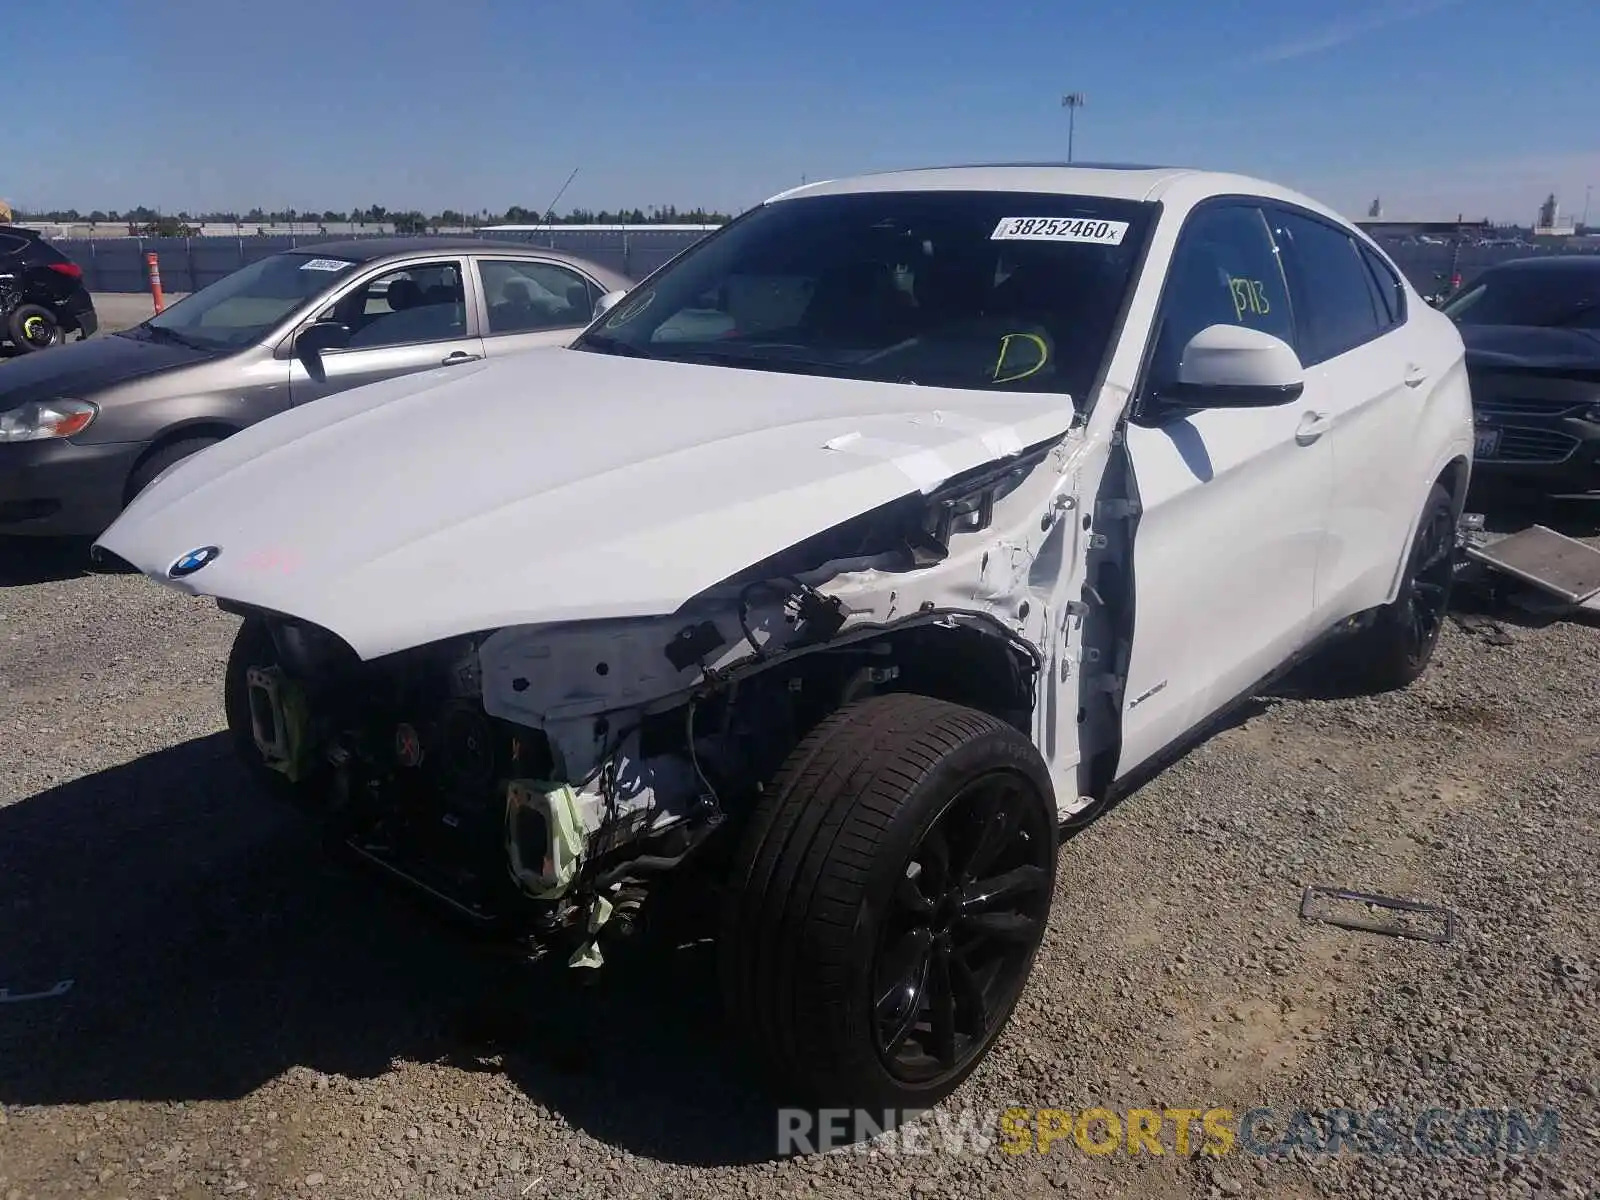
[{"left": 54, "top": 226, "right": 1595, "bottom": 294}]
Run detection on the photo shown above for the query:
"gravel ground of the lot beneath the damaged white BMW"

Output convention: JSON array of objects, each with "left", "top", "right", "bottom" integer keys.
[{"left": 0, "top": 508, "right": 1600, "bottom": 1200}]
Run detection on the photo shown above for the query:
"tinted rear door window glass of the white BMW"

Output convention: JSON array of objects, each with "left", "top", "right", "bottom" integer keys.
[{"left": 1274, "top": 211, "right": 1389, "bottom": 366}]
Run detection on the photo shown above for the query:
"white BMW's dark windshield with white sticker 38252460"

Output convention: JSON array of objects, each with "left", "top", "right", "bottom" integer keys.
[{"left": 576, "top": 192, "right": 1152, "bottom": 397}]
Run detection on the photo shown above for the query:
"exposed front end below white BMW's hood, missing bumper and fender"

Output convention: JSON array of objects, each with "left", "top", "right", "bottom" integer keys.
[{"left": 219, "top": 437, "right": 1126, "bottom": 965}]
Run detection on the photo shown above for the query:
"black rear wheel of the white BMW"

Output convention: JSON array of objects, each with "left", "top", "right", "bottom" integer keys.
[{"left": 1339, "top": 483, "right": 1456, "bottom": 693}]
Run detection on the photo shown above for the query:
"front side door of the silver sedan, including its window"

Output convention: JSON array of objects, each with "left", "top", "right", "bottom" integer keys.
[{"left": 290, "top": 256, "right": 483, "bottom": 405}]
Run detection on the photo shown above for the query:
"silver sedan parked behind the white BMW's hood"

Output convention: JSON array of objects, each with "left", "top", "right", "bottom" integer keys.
[{"left": 0, "top": 237, "right": 632, "bottom": 536}]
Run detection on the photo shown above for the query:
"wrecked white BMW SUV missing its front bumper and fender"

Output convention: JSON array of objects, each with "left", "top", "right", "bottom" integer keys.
[{"left": 101, "top": 165, "right": 1472, "bottom": 1109}]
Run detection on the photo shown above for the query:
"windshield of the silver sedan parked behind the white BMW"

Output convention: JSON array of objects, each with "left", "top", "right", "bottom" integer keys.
[{"left": 139, "top": 251, "right": 357, "bottom": 349}]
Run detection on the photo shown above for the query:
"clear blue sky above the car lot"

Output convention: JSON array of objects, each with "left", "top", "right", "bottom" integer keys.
[{"left": 12, "top": 0, "right": 1600, "bottom": 221}]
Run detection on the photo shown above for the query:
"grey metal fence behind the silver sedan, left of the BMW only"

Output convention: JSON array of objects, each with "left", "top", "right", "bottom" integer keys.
[{"left": 51, "top": 226, "right": 720, "bottom": 291}]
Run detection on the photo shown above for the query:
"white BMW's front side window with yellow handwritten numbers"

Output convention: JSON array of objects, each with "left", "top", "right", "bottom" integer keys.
[{"left": 1150, "top": 205, "right": 1294, "bottom": 387}]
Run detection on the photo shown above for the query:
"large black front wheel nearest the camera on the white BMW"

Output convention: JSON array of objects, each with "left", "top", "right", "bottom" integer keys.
[{"left": 718, "top": 694, "right": 1056, "bottom": 1112}]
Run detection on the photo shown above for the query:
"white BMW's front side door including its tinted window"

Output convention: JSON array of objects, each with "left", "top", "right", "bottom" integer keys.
[{"left": 1120, "top": 200, "right": 1333, "bottom": 773}]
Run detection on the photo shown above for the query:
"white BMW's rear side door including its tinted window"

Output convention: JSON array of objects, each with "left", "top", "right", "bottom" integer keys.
[{"left": 1269, "top": 205, "right": 1443, "bottom": 626}]
